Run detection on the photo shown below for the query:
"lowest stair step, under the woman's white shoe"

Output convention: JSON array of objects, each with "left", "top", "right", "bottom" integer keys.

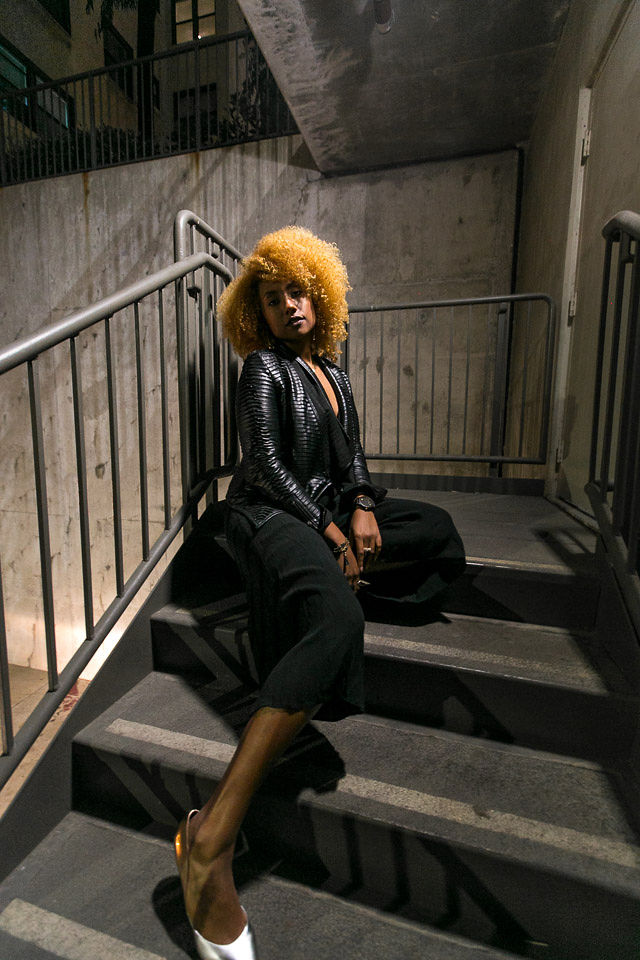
[{"left": 0, "top": 813, "right": 513, "bottom": 960}]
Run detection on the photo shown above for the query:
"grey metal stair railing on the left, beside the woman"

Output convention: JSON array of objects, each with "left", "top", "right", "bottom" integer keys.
[{"left": 0, "top": 217, "right": 239, "bottom": 784}]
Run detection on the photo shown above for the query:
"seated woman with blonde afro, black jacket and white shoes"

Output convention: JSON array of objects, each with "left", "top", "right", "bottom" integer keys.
[{"left": 176, "top": 227, "right": 464, "bottom": 960}]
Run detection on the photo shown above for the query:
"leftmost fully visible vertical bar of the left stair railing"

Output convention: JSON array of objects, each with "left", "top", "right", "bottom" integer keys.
[{"left": 27, "top": 358, "right": 58, "bottom": 690}]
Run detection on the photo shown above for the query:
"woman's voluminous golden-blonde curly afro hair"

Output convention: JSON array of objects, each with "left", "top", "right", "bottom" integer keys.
[{"left": 218, "top": 227, "right": 351, "bottom": 360}]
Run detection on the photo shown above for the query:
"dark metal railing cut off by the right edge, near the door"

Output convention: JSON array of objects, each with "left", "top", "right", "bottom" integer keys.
[{"left": 585, "top": 210, "right": 640, "bottom": 635}]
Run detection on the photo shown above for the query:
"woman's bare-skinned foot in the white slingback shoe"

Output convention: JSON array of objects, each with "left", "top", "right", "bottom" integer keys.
[{"left": 174, "top": 810, "right": 250, "bottom": 944}]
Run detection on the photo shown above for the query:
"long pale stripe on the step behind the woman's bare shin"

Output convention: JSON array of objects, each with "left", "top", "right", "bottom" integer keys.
[{"left": 107, "top": 719, "right": 640, "bottom": 868}]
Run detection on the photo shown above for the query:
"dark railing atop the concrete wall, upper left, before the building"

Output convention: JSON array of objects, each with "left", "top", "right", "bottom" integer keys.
[{"left": 0, "top": 31, "right": 297, "bottom": 186}]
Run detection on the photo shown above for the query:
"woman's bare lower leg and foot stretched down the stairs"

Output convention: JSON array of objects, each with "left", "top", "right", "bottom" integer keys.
[{"left": 176, "top": 707, "right": 315, "bottom": 944}]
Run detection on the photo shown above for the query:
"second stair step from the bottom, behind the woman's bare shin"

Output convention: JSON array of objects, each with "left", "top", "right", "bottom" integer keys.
[{"left": 74, "top": 674, "right": 640, "bottom": 960}]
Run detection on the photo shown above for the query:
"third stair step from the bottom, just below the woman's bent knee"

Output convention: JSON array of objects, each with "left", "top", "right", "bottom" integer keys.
[{"left": 152, "top": 598, "right": 638, "bottom": 760}]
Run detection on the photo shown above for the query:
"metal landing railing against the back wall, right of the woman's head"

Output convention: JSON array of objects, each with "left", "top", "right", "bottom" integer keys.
[{"left": 344, "top": 293, "right": 555, "bottom": 469}]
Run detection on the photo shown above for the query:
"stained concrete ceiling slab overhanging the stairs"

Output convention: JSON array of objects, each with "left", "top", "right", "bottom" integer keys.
[{"left": 239, "top": 0, "right": 569, "bottom": 173}]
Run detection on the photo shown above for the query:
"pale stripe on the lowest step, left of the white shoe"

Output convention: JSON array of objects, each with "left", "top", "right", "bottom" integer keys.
[{"left": 0, "top": 900, "right": 168, "bottom": 960}]
